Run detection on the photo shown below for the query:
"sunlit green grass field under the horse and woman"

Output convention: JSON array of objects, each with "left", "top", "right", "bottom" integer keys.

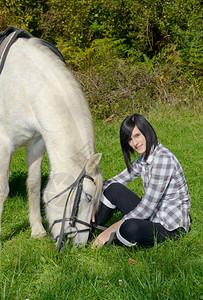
[{"left": 0, "top": 107, "right": 203, "bottom": 300}]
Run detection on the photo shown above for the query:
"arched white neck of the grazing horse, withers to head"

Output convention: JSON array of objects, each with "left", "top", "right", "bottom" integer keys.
[{"left": 11, "top": 39, "right": 94, "bottom": 172}]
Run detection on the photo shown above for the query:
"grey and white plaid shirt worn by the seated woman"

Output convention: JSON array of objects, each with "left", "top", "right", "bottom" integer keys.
[{"left": 104, "top": 144, "right": 190, "bottom": 232}]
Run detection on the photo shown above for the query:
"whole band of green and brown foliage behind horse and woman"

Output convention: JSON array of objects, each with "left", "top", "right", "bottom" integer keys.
[{"left": 0, "top": 0, "right": 203, "bottom": 118}]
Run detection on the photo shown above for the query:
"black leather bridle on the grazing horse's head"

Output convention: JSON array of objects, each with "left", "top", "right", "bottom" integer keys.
[{"left": 46, "top": 169, "right": 106, "bottom": 252}]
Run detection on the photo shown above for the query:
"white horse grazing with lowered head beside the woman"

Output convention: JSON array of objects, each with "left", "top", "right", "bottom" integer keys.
[{"left": 0, "top": 38, "right": 102, "bottom": 248}]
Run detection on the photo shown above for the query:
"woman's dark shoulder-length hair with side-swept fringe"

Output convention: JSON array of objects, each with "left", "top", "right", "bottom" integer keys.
[{"left": 120, "top": 114, "right": 158, "bottom": 171}]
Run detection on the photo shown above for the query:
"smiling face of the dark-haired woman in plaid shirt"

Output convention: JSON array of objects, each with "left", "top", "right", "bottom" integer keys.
[{"left": 128, "top": 126, "right": 146, "bottom": 154}]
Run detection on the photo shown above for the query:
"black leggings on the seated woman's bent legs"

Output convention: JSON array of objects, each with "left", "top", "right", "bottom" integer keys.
[{"left": 104, "top": 183, "right": 185, "bottom": 246}]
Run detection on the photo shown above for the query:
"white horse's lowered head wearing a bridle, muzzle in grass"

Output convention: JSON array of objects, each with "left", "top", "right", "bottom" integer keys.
[{"left": 44, "top": 154, "right": 103, "bottom": 249}]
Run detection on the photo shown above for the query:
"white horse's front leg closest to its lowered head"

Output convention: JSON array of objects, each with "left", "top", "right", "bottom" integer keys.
[{"left": 26, "top": 139, "right": 46, "bottom": 237}]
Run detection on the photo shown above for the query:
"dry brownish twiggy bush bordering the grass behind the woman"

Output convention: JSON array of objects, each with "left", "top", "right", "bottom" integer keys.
[{"left": 76, "top": 49, "right": 202, "bottom": 119}]
